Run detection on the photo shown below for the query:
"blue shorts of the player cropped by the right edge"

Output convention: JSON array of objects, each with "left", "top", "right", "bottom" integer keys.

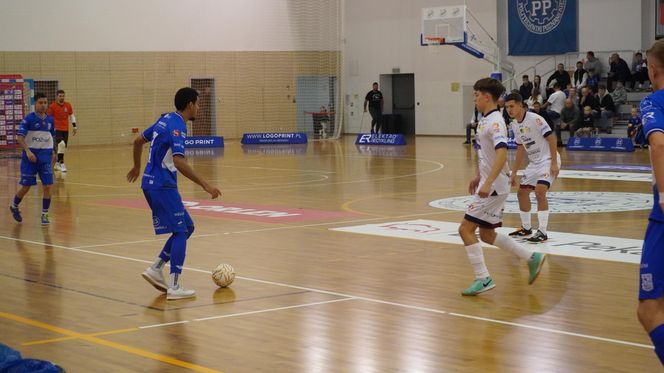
[{"left": 639, "top": 220, "right": 664, "bottom": 299}]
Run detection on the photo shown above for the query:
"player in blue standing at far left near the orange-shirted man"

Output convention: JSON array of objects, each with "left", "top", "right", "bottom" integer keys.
[{"left": 9, "top": 93, "right": 55, "bottom": 225}]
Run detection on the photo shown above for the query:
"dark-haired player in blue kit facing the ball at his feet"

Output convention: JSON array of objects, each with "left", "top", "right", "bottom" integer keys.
[{"left": 127, "top": 88, "right": 221, "bottom": 300}]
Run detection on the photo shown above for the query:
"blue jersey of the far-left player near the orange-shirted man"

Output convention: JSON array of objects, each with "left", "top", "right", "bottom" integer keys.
[{"left": 17, "top": 112, "right": 55, "bottom": 162}]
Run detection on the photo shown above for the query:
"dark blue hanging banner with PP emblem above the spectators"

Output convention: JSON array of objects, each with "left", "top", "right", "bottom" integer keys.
[{"left": 508, "top": 0, "right": 578, "bottom": 56}]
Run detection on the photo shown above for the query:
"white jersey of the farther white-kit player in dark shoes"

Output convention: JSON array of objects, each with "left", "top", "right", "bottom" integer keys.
[{"left": 512, "top": 111, "right": 560, "bottom": 165}]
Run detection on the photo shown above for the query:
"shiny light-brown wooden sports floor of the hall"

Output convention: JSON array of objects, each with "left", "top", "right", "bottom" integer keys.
[{"left": 0, "top": 137, "right": 662, "bottom": 372}]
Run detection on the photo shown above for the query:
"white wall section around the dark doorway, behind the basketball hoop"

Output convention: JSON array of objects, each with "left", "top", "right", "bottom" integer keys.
[{"left": 344, "top": 0, "right": 496, "bottom": 135}]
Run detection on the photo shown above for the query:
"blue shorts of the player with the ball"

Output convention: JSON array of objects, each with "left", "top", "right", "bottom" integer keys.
[{"left": 143, "top": 189, "right": 194, "bottom": 234}]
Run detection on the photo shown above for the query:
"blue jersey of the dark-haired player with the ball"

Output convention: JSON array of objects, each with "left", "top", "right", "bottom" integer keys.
[{"left": 141, "top": 112, "right": 187, "bottom": 190}]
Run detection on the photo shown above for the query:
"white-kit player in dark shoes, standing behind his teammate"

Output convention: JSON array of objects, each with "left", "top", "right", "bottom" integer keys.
[{"left": 505, "top": 93, "right": 560, "bottom": 243}]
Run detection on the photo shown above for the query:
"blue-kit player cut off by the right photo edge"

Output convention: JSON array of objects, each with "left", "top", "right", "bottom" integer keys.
[{"left": 637, "top": 40, "right": 664, "bottom": 364}]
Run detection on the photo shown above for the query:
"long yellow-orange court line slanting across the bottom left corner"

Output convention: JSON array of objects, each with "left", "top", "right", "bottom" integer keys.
[{"left": 0, "top": 312, "right": 222, "bottom": 373}]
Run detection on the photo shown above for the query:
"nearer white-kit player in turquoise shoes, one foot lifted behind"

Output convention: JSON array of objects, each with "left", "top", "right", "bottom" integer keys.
[{"left": 459, "top": 78, "right": 546, "bottom": 295}]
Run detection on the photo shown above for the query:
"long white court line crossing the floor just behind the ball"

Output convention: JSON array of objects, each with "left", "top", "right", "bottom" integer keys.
[{"left": 0, "top": 231, "right": 654, "bottom": 349}]
